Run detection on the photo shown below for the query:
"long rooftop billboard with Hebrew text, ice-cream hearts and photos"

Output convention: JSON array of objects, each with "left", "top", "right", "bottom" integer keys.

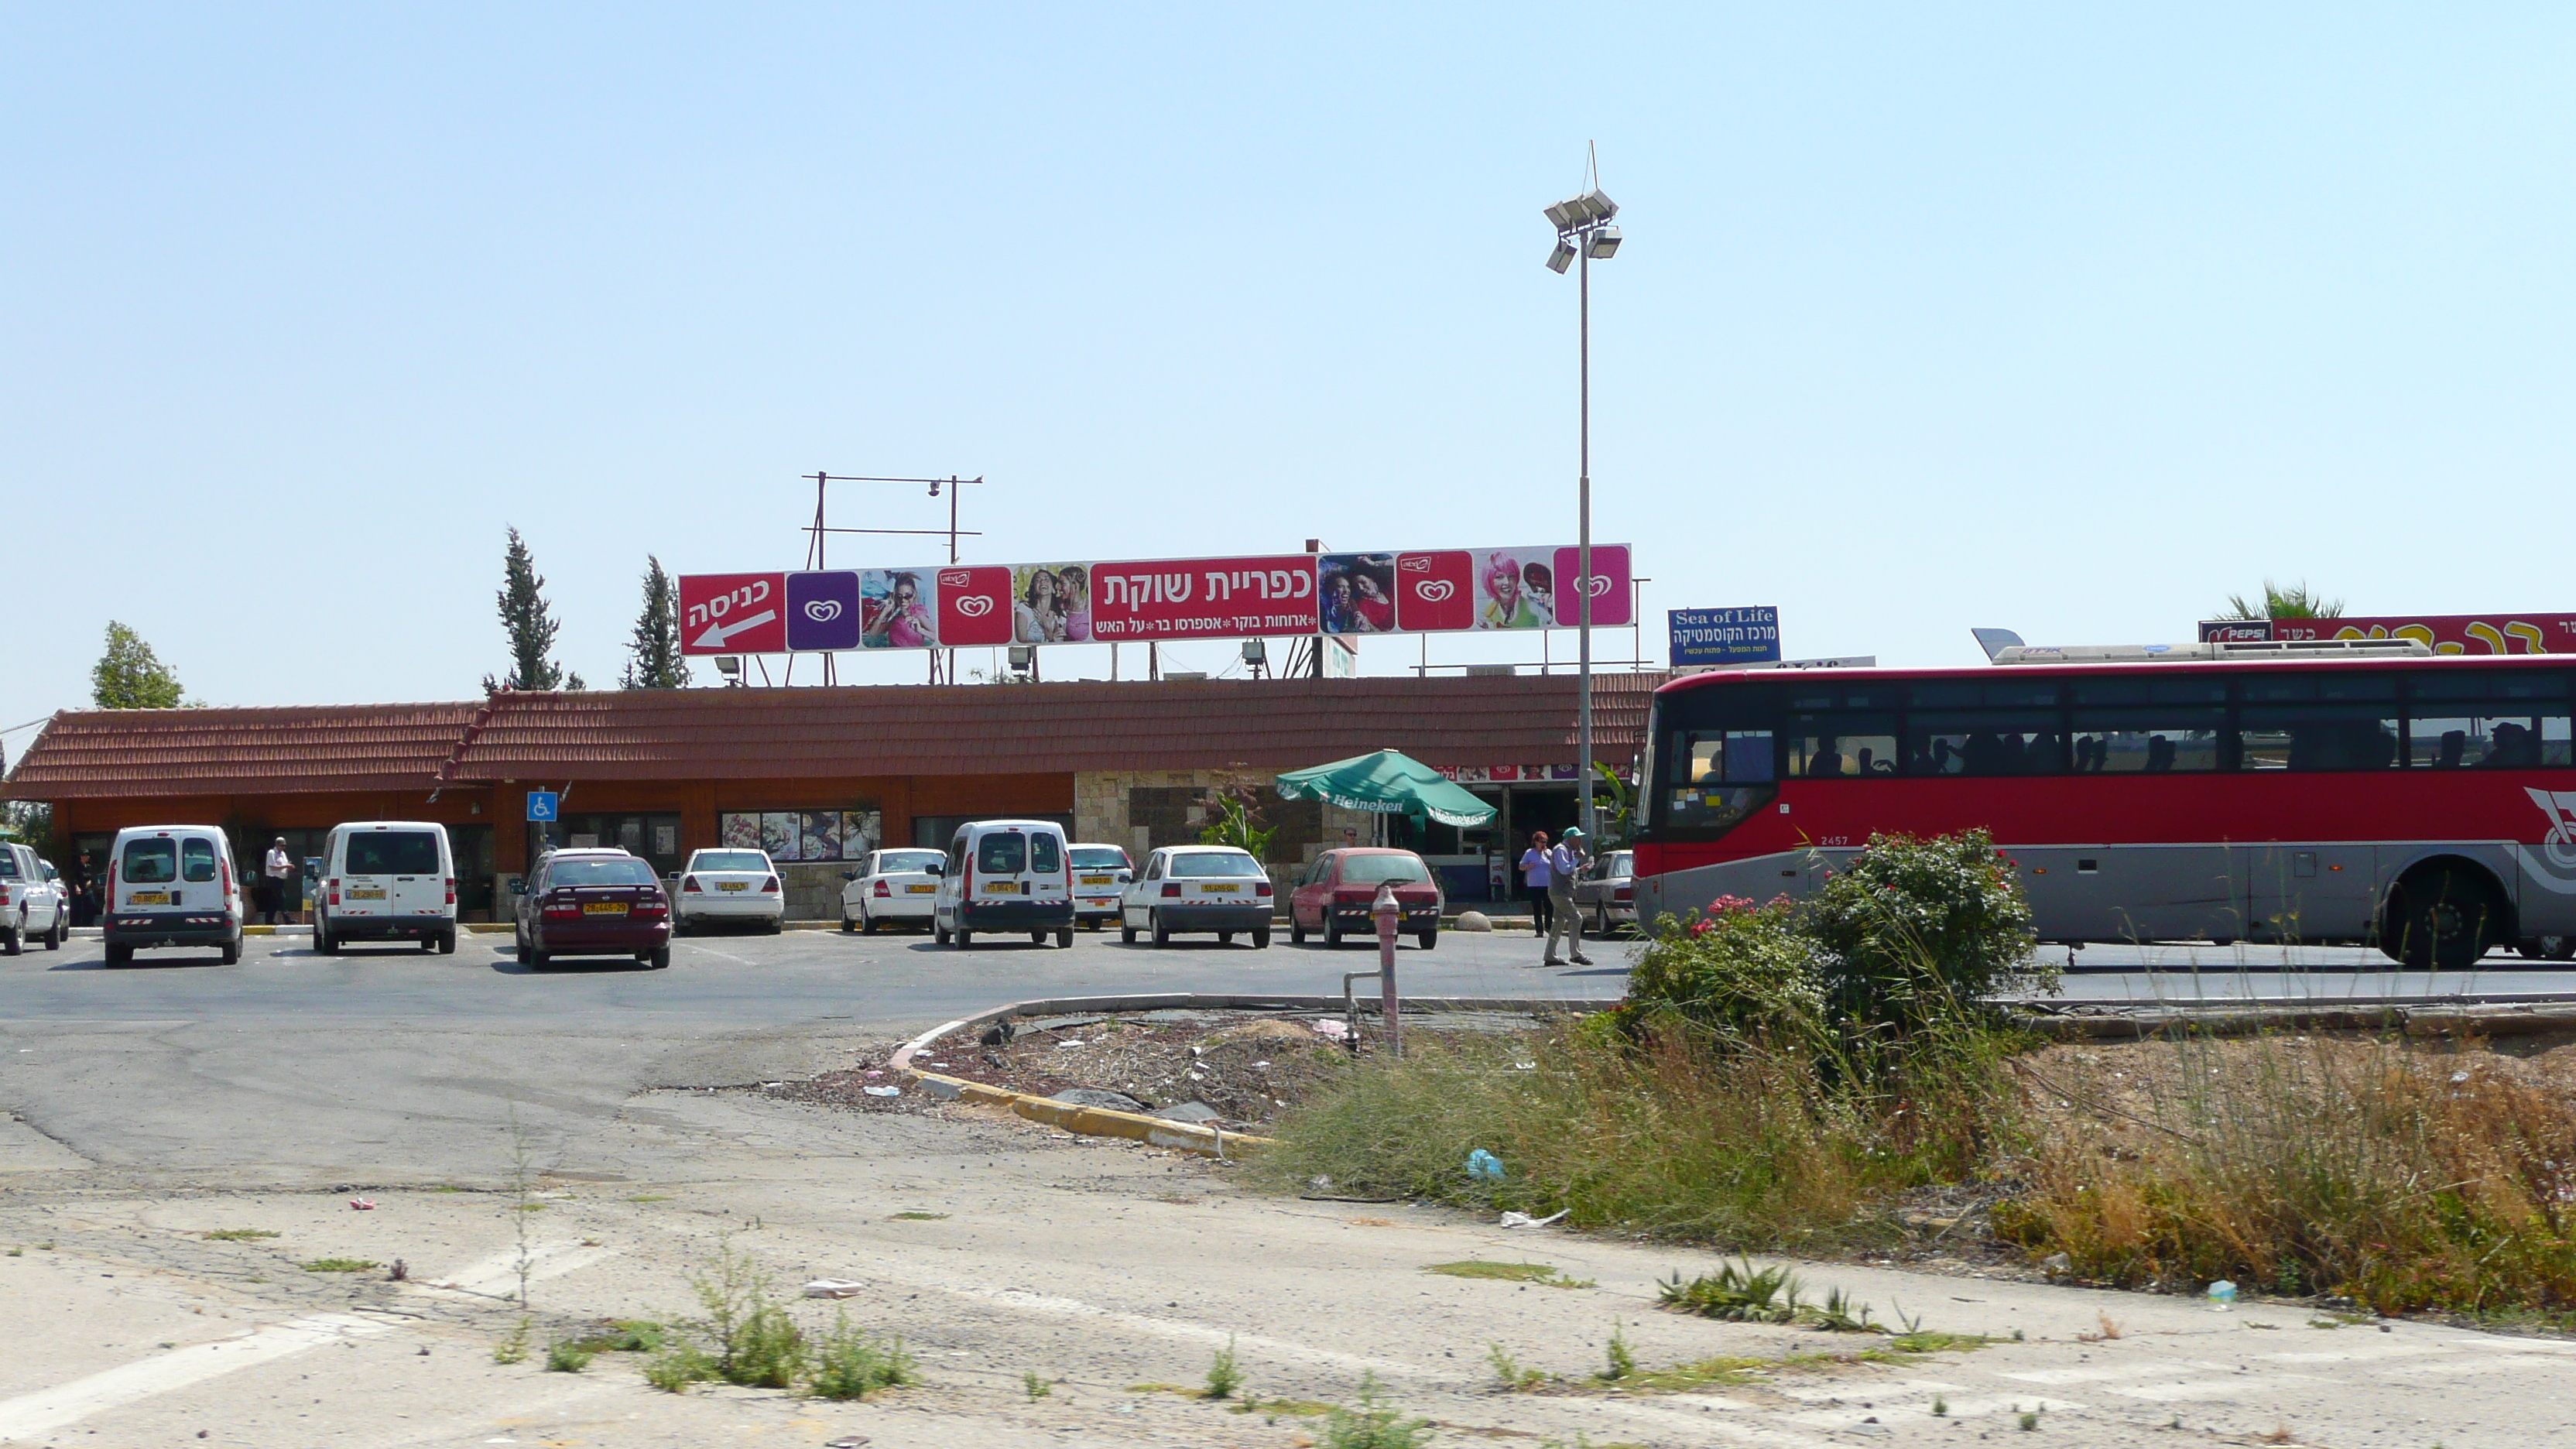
[{"left": 680, "top": 544, "right": 1633, "bottom": 655}]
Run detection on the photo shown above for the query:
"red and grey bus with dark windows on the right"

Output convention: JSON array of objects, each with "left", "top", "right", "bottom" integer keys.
[{"left": 1636, "top": 649, "right": 2576, "bottom": 969}]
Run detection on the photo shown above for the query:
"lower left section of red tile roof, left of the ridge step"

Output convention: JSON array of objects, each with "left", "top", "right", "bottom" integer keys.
[{"left": 8, "top": 701, "right": 481, "bottom": 800}]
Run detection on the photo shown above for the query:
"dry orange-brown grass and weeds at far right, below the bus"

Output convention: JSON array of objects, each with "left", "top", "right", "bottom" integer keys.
[{"left": 1994, "top": 1036, "right": 2576, "bottom": 1315}]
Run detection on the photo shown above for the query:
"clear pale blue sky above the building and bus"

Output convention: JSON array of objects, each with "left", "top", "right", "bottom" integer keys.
[{"left": 0, "top": 5, "right": 2576, "bottom": 731}]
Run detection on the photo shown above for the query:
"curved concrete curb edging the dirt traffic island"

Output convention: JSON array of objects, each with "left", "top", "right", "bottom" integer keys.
[{"left": 886, "top": 992, "right": 1618, "bottom": 1160}]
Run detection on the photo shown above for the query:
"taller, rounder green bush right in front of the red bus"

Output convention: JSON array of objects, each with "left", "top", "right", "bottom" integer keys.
[{"left": 1800, "top": 831, "right": 2058, "bottom": 1023}]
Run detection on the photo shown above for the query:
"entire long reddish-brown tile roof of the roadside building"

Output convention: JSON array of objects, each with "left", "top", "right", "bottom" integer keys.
[{"left": 8, "top": 676, "right": 1664, "bottom": 800}]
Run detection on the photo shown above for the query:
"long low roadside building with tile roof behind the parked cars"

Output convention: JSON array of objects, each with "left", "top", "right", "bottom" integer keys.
[{"left": 0, "top": 673, "right": 1664, "bottom": 920}]
